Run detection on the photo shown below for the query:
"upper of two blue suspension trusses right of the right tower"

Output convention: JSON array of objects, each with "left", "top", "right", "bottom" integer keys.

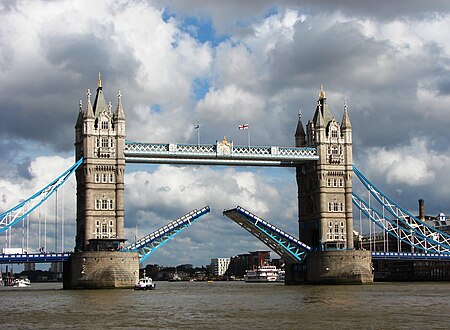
[{"left": 353, "top": 166, "right": 450, "bottom": 252}]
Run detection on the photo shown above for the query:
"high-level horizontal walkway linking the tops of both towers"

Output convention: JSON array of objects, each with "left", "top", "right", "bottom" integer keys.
[{"left": 124, "top": 140, "right": 319, "bottom": 167}]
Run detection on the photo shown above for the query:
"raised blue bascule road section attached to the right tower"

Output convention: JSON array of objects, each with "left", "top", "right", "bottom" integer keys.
[{"left": 223, "top": 206, "right": 311, "bottom": 263}]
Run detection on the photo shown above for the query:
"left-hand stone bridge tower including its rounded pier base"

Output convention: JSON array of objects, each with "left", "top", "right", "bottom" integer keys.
[{"left": 64, "top": 73, "right": 139, "bottom": 288}]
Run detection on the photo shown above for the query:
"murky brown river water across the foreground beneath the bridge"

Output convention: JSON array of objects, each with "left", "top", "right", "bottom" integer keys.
[{"left": 0, "top": 282, "right": 450, "bottom": 329}]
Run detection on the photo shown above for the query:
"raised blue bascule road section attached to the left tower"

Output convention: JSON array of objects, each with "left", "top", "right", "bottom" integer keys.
[{"left": 124, "top": 206, "right": 210, "bottom": 263}]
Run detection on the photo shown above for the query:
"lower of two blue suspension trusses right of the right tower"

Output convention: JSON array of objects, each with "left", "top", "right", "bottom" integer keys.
[{"left": 352, "top": 193, "right": 450, "bottom": 254}]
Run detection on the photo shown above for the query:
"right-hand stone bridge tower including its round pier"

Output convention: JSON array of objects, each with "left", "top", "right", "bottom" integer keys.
[{"left": 295, "top": 86, "right": 372, "bottom": 283}]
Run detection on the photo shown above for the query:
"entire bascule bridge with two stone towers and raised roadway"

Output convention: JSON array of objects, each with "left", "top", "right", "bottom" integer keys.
[{"left": 0, "top": 76, "right": 450, "bottom": 288}]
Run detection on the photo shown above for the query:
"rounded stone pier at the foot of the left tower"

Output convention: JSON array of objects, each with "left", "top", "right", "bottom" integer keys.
[{"left": 63, "top": 251, "right": 139, "bottom": 289}]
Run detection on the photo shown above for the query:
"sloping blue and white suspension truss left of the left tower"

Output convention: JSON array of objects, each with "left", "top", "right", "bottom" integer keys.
[{"left": 0, "top": 158, "right": 83, "bottom": 233}]
